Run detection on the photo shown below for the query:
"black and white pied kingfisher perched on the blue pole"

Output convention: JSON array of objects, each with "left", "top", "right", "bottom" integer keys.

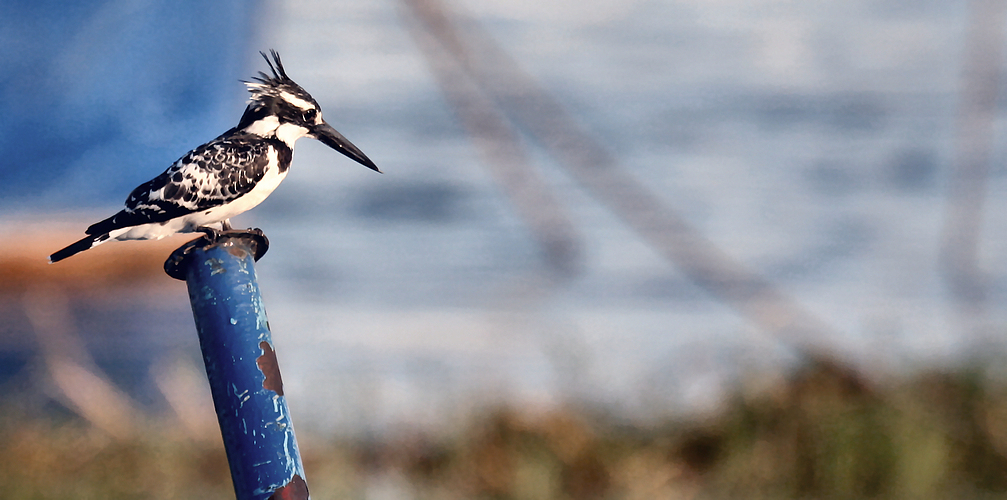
[{"left": 49, "top": 49, "right": 381, "bottom": 264}]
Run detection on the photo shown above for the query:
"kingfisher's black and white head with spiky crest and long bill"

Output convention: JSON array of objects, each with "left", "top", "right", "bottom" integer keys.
[{"left": 237, "top": 50, "right": 380, "bottom": 172}]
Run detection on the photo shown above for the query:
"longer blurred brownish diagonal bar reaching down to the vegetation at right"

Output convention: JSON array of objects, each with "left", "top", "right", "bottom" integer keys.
[{"left": 403, "top": 0, "right": 848, "bottom": 366}]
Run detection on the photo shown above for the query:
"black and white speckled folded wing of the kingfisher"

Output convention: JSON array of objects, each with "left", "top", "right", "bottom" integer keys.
[{"left": 87, "top": 136, "right": 269, "bottom": 234}]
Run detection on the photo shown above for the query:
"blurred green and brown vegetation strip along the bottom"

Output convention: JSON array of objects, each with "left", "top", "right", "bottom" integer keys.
[{"left": 0, "top": 365, "right": 1007, "bottom": 500}]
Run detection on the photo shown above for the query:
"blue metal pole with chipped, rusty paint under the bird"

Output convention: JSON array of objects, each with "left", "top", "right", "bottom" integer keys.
[{"left": 164, "top": 231, "right": 308, "bottom": 500}]
